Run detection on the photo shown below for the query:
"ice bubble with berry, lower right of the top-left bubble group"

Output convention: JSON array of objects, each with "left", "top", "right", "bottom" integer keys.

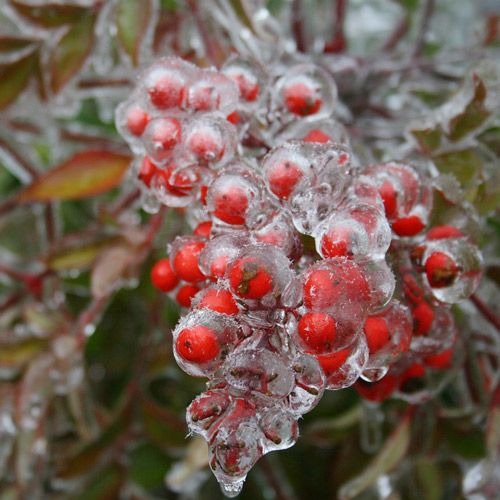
[{"left": 183, "top": 113, "right": 237, "bottom": 168}]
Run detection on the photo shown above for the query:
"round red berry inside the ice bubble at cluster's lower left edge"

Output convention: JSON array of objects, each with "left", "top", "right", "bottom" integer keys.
[{"left": 175, "top": 325, "right": 219, "bottom": 364}]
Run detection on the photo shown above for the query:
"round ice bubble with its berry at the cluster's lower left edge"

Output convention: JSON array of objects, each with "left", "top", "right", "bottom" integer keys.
[{"left": 172, "top": 309, "right": 238, "bottom": 377}]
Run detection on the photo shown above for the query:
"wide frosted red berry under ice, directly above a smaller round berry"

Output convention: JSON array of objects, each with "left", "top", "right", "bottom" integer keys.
[{"left": 302, "top": 261, "right": 371, "bottom": 310}]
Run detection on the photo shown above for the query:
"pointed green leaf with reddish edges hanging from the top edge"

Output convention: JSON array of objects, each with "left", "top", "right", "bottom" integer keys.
[{"left": 116, "top": 0, "right": 153, "bottom": 66}]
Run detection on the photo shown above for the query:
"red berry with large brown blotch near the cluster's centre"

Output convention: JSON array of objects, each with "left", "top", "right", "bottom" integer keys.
[{"left": 229, "top": 257, "right": 273, "bottom": 299}]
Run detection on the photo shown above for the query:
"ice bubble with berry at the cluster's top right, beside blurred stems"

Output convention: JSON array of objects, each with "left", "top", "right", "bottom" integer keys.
[{"left": 273, "top": 64, "right": 337, "bottom": 117}]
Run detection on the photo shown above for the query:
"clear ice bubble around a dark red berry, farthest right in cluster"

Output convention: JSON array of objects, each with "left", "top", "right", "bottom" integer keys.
[{"left": 422, "top": 238, "right": 483, "bottom": 304}]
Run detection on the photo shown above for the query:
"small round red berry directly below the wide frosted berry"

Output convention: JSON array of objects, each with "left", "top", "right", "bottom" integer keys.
[{"left": 298, "top": 313, "right": 337, "bottom": 354}]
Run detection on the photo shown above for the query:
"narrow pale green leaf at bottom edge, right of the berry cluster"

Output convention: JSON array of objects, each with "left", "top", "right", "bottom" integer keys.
[{"left": 339, "top": 415, "right": 410, "bottom": 500}]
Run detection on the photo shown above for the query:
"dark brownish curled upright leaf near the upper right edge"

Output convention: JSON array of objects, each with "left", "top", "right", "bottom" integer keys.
[{"left": 448, "top": 74, "right": 491, "bottom": 142}]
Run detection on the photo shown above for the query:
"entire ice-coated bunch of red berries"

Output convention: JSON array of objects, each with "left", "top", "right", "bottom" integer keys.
[{"left": 117, "top": 58, "right": 482, "bottom": 495}]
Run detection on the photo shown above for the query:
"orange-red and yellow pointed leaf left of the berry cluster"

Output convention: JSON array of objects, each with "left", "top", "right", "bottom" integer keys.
[{"left": 18, "top": 151, "right": 130, "bottom": 203}]
